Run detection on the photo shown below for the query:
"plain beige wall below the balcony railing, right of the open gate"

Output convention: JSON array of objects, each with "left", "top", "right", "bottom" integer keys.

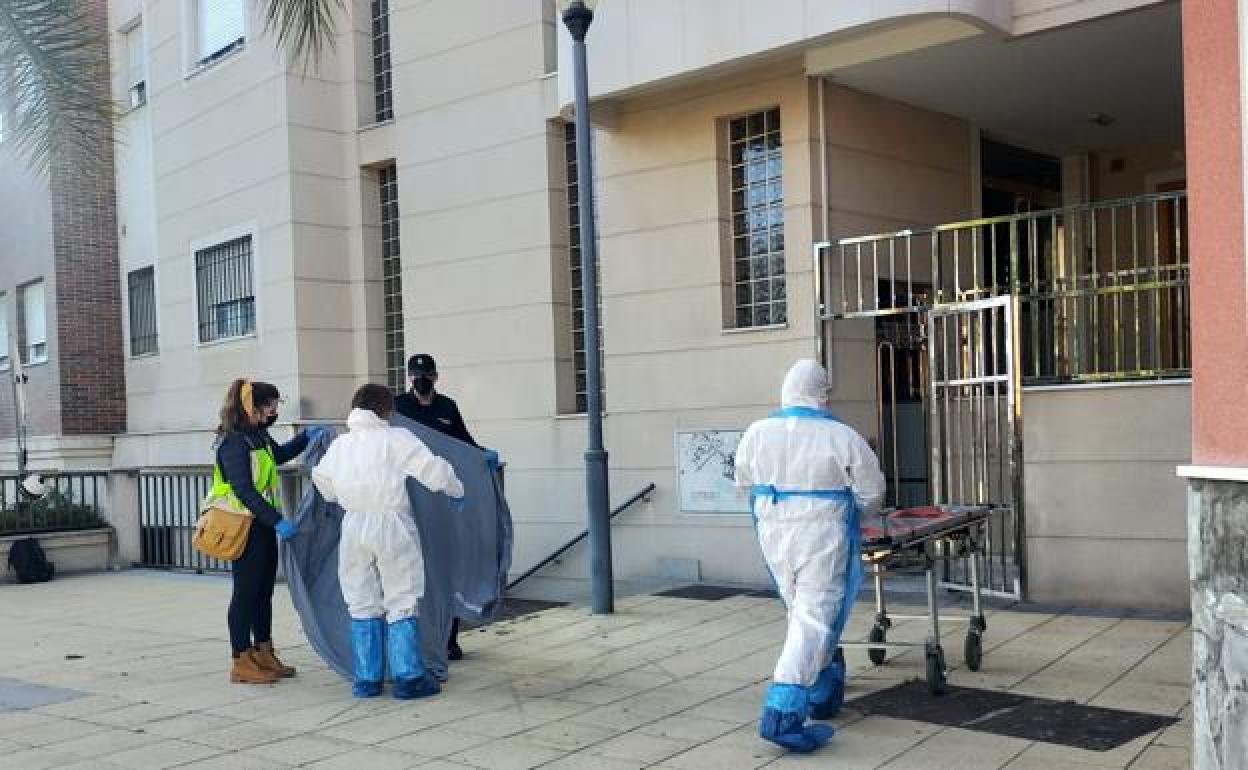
[{"left": 1023, "top": 384, "right": 1192, "bottom": 609}]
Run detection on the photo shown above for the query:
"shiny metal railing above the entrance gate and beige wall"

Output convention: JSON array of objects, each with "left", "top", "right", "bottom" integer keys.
[{"left": 816, "top": 192, "right": 1192, "bottom": 384}]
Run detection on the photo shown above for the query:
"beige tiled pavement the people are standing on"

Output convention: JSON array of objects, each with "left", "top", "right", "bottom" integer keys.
[{"left": 0, "top": 572, "right": 1191, "bottom": 770}]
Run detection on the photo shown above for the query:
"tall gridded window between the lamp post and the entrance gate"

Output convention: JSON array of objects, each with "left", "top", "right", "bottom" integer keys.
[{"left": 729, "top": 109, "right": 787, "bottom": 328}]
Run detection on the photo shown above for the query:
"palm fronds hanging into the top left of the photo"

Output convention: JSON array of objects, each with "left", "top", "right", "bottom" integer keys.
[{"left": 0, "top": 0, "right": 343, "bottom": 173}]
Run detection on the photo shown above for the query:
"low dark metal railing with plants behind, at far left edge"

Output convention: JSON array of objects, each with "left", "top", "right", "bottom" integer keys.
[{"left": 0, "top": 470, "right": 109, "bottom": 535}]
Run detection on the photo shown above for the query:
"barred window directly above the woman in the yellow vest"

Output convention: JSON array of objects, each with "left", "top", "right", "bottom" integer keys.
[{"left": 195, "top": 236, "right": 256, "bottom": 342}]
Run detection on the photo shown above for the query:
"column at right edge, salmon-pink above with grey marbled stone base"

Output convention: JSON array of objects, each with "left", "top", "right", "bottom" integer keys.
[{"left": 1179, "top": 0, "right": 1248, "bottom": 770}]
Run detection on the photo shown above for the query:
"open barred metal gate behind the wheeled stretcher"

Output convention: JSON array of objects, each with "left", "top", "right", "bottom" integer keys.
[{"left": 927, "top": 296, "right": 1023, "bottom": 599}]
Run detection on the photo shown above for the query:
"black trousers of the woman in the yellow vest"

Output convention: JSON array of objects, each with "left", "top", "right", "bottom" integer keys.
[{"left": 227, "top": 520, "right": 277, "bottom": 655}]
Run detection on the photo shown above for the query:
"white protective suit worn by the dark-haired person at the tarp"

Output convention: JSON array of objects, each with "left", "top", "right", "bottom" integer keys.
[{"left": 312, "top": 409, "right": 464, "bottom": 623}]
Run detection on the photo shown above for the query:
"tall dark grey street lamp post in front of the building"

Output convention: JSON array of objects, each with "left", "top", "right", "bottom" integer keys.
[{"left": 562, "top": 0, "right": 615, "bottom": 615}]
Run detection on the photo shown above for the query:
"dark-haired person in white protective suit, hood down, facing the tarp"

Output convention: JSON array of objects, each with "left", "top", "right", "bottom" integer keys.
[{"left": 312, "top": 384, "right": 464, "bottom": 699}]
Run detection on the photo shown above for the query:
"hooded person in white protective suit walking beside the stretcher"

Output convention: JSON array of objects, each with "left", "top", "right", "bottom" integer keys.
[{"left": 736, "top": 358, "right": 885, "bottom": 751}]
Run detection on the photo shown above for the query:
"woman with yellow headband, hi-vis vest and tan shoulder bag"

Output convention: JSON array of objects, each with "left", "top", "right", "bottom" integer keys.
[{"left": 213, "top": 379, "right": 323, "bottom": 684}]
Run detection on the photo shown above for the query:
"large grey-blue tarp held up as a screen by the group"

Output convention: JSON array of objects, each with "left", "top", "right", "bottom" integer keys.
[{"left": 282, "top": 416, "right": 512, "bottom": 680}]
